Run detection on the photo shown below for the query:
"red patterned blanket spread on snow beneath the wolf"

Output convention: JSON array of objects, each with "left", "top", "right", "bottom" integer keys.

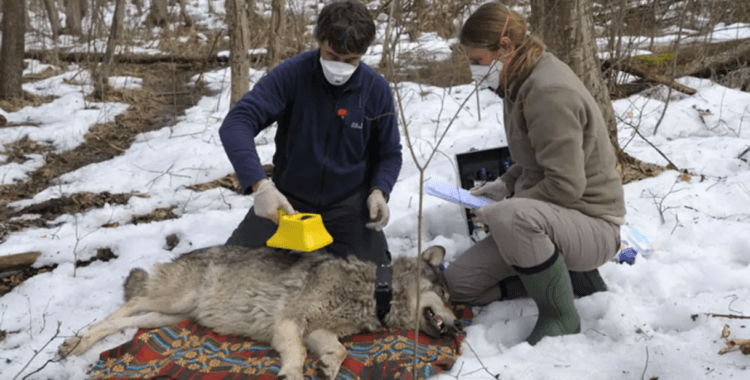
[{"left": 91, "top": 307, "right": 472, "bottom": 380}]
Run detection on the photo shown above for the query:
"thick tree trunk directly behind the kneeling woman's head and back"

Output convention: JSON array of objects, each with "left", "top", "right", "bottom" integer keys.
[{"left": 530, "top": 0, "right": 620, "bottom": 152}]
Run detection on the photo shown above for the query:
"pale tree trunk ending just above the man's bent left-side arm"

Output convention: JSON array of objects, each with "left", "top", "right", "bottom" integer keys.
[{"left": 225, "top": 0, "right": 250, "bottom": 109}]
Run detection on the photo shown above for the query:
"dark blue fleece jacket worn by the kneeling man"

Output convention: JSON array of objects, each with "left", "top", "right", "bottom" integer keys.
[{"left": 219, "top": 50, "right": 402, "bottom": 207}]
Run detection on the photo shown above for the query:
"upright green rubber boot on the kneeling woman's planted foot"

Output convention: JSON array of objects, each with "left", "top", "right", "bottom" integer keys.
[{"left": 516, "top": 251, "right": 581, "bottom": 346}]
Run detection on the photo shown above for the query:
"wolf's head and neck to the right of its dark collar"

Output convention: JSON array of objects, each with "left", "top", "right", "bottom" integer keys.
[{"left": 385, "top": 246, "right": 462, "bottom": 336}]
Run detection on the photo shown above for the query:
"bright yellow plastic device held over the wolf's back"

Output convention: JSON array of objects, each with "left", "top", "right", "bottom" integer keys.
[{"left": 266, "top": 209, "right": 333, "bottom": 252}]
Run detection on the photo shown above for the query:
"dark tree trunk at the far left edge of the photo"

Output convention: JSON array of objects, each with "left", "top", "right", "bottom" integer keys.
[{"left": 0, "top": 0, "right": 26, "bottom": 99}]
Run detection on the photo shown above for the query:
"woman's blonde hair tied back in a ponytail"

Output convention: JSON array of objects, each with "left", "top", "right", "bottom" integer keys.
[{"left": 459, "top": 1, "right": 545, "bottom": 89}]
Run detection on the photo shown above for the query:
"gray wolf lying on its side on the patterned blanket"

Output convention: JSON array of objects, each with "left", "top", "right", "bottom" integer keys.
[{"left": 59, "top": 246, "right": 461, "bottom": 380}]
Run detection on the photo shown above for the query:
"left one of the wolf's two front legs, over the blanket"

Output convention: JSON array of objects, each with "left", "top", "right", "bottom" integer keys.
[{"left": 271, "top": 319, "right": 307, "bottom": 380}]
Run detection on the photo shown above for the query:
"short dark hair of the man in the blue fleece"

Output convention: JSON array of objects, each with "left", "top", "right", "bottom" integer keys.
[{"left": 313, "top": 0, "right": 375, "bottom": 54}]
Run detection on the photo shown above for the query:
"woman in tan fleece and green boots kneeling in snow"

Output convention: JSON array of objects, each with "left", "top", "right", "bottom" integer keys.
[{"left": 445, "top": 2, "right": 625, "bottom": 345}]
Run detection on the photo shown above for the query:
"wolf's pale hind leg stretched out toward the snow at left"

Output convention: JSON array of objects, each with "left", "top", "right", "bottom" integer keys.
[{"left": 59, "top": 312, "right": 188, "bottom": 357}]
